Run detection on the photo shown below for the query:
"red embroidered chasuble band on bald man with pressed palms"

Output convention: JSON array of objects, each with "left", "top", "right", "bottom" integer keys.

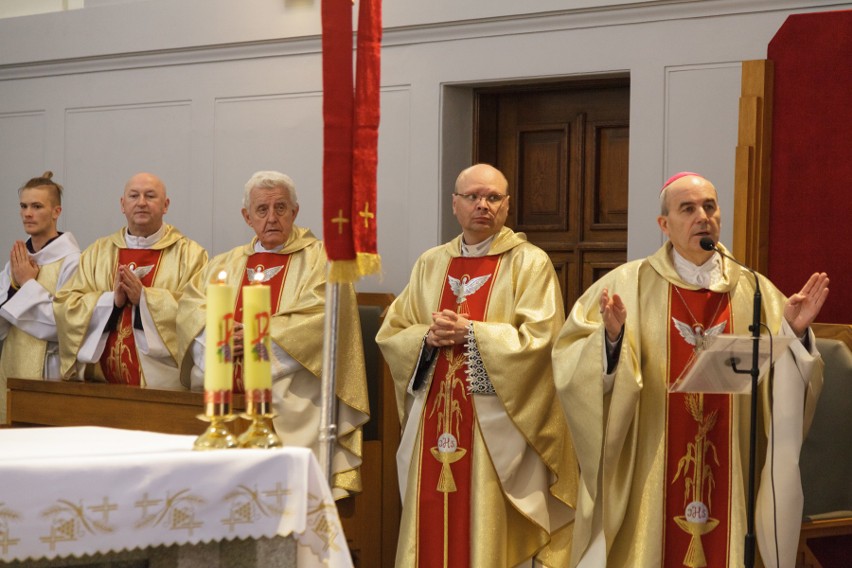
[{"left": 100, "top": 249, "right": 162, "bottom": 387}]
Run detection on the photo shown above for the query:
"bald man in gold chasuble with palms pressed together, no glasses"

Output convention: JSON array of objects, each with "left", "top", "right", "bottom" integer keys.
[{"left": 54, "top": 173, "right": 207, "bottom": 388}]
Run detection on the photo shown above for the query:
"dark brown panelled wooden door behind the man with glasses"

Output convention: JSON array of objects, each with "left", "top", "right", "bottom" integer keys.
[{"left": 474, "top": 77, "right": 630, "bottom": 311}]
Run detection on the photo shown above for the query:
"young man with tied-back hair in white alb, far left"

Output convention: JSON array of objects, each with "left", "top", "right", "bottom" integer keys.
[{"left": 0, "top": 172, "right": 80, "bottom": 423}]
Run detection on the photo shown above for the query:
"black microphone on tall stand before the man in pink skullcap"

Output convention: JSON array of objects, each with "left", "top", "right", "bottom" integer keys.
[{"left": 701, "top": 237, "right": 761, "bottom": 568}]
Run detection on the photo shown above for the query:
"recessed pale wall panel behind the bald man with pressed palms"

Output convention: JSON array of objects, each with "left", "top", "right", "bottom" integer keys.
[{"left": 64, "top": 101, "right": 193, "bottom": 248}]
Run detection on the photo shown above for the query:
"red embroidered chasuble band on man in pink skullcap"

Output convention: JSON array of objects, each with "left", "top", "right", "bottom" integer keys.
[{"left": 663, "top": 286, "right": 733, "bottom": 567}]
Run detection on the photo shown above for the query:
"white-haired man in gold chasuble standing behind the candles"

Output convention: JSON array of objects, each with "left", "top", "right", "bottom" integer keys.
[{"left": 178, "top": 171, "right": 369, "bottom": 498}]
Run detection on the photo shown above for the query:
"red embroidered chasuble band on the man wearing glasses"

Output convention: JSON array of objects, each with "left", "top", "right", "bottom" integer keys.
[{"left": 417, "top": 255, "right": 500, "bottom": 568}]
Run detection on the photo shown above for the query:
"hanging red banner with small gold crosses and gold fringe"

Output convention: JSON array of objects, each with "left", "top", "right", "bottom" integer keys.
[{"left": 322, "top": 0, "right": 382, "bottom": 282}]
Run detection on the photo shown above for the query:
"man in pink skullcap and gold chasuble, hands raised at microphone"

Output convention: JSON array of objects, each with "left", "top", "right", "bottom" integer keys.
[{"left": 553, "top": 172, "right": 828, "bottom": 568}]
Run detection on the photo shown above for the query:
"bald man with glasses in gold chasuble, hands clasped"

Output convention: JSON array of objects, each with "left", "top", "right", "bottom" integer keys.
[{"left": 376, "top": 164, "right": 577, "bottom": 567}]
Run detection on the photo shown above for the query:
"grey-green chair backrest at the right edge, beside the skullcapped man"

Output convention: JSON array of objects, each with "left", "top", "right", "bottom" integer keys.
[{"left": 799, "top": 338, "right": 852, "bottom": 517}]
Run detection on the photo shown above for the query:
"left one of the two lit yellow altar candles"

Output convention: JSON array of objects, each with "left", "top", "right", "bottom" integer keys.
[{"left": 204, "top": 271, "right": 234, "bottom": 394}]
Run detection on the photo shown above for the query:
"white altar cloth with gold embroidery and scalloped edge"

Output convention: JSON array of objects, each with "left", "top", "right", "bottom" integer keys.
[{"left": 0, "top": 427, "right": 352, "bottom": 568}]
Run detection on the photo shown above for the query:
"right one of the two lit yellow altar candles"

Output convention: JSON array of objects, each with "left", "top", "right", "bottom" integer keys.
[{"left": 243, "top": 275, "right": 272, "bottom": 394}]
